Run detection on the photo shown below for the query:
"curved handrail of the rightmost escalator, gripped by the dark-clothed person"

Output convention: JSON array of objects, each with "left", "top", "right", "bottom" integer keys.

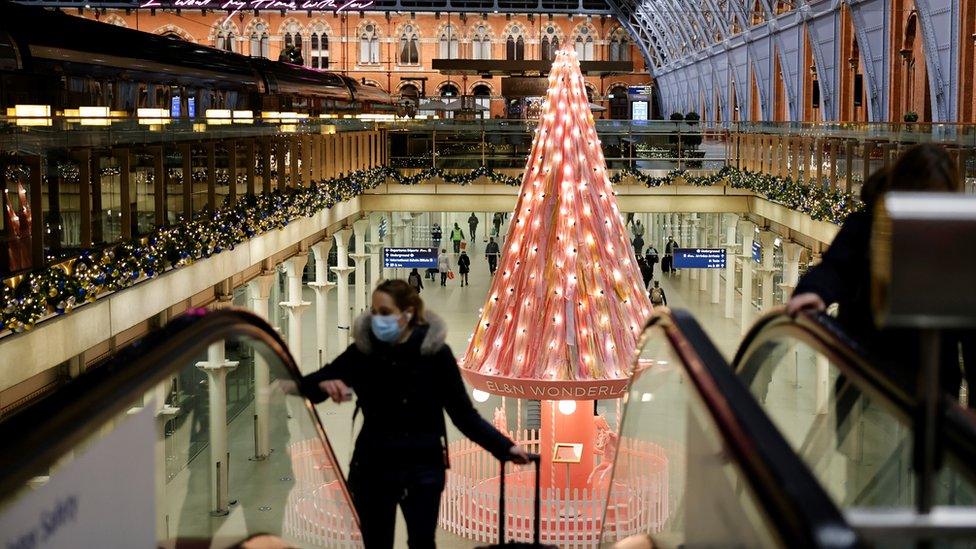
[{"left": 732, "top": 308, "right": 976, "bottom": 479}]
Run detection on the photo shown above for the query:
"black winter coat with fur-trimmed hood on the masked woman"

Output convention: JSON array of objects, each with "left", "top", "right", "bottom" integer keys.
[{"left": 300, "top": 313, "right": 515, "bottom": 469}]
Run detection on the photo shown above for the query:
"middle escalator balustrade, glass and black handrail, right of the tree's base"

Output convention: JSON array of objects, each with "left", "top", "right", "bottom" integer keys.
[{"left": 602, "top": 317, "right": 854, "bottom": 547}]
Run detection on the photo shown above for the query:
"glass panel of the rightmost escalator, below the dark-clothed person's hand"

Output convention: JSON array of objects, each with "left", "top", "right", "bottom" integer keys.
[{"left": 736, "top": 314, "right": 976, "bottom": 509}]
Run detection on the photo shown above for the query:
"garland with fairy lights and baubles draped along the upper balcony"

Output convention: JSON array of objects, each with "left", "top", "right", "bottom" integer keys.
[{"left": 0, "top": 166, "right": 862, "bottom": 332}]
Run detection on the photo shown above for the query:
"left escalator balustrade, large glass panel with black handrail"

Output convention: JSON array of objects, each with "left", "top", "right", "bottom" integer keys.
[{"left": 0, "top": 310, "right": 361, "bottom": 548}]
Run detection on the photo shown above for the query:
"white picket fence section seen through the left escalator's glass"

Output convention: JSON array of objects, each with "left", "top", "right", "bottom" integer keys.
[{"left": 282, "top": 439, "right": 363, "bottom": 549}]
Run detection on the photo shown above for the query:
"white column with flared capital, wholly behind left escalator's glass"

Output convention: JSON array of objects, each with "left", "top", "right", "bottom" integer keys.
[{"left": 196, "top": 332, "right": 238, "bottom": 517}]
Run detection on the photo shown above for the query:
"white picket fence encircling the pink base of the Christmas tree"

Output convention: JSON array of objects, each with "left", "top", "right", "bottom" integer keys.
[{"left": 439, "top": 431, "right": 668, "bottom": 549}]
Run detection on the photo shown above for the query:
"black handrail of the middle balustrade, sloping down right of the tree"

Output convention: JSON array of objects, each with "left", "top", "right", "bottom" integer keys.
[{"left": 624, "top": 309, "right": 859, "bottom": 548}]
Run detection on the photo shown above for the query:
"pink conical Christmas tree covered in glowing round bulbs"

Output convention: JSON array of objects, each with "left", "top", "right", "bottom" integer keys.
[{"left": 463, "top": 46, "right": 651, "bottom": 390}]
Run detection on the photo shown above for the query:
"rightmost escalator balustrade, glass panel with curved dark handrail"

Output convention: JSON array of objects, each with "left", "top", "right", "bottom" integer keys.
[{"left": 733, "top": 312, "right": 976, "bottom": 547}]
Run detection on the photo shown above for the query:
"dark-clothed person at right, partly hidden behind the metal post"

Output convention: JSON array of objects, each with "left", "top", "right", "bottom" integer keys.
[{"left": 786, "top": 144, "right": 976, "bottom": 402}]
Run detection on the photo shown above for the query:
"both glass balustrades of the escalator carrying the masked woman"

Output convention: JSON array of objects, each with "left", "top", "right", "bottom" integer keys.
[{"left": 0, "top": 310, "right": 858, "bottom": 547}]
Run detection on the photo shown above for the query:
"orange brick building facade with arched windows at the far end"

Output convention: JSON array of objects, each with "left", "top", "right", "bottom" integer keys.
[{"left": 85, "top": 10, "right": 651, "bottom": 118}]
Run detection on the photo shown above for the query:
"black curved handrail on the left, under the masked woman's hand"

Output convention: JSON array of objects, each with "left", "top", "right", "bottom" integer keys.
[{"left": 0, "top": 309, "right": 359, "bottom": 527}]
